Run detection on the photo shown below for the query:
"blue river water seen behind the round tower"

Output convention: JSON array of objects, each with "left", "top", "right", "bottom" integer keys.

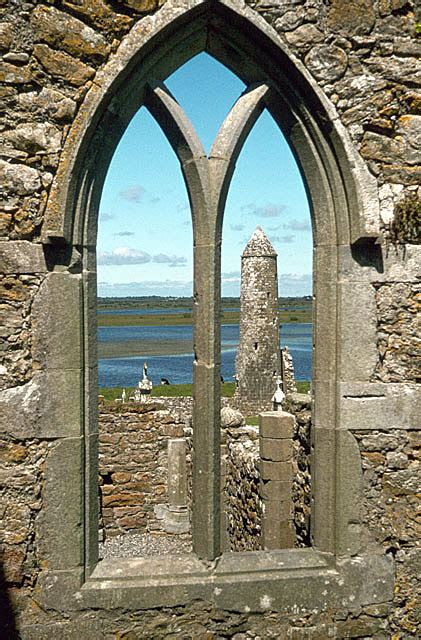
[{"left": 98, "top": 324, "right": 312, "bottom": 388}]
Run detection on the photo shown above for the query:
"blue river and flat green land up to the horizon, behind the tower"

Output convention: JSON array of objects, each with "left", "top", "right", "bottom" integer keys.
[{"left": 97, "top": 297, "right": 312, "bottom": 388}]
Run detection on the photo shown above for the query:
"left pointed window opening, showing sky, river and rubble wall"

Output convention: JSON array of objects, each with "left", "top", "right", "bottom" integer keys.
[{"left": 97, "top": 108, "right": 193, "bottom": 557}]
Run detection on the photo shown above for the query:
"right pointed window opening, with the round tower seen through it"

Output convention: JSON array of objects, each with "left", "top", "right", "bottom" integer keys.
[{"left": 221, "top": 111, "right": 312, "bottom": 551}]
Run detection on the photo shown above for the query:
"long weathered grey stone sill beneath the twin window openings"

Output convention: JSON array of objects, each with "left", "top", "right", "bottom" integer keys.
[{"left": 34, "top": 549, "right": 393, "bottom": 613}]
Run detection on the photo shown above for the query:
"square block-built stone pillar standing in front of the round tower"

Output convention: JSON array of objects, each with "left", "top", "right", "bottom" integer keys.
[{"left": 259, "top": 411, "right": 295, "bottom": 549}]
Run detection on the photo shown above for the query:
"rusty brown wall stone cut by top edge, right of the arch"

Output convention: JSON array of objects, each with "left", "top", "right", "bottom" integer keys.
[{"left": 328, "top": 0, "right": 375, "bottom": 35}]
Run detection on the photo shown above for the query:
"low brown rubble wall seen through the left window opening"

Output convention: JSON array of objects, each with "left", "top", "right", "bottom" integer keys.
[{"left": 99, "top": 402, "right": 184, "bottom": 537}]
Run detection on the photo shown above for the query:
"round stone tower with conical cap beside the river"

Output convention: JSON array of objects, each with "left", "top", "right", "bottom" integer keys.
[{"left": 234, "top": 227, "right": 280, "bottom": 415}]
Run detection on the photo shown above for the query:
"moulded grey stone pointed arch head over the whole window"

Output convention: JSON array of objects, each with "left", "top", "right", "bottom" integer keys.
[{"left": 42, "top": 0, "right": 378, "bottom": 245}]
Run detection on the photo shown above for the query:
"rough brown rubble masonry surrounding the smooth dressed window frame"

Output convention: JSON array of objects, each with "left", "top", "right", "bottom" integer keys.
[{"left": 0, "top": 0, "right": 421, "bottom": 640}]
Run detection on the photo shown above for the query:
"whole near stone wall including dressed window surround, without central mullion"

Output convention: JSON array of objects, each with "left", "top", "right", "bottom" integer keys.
[{"left": 0, "top": 0, "right": 421, "bottom": 640}]
